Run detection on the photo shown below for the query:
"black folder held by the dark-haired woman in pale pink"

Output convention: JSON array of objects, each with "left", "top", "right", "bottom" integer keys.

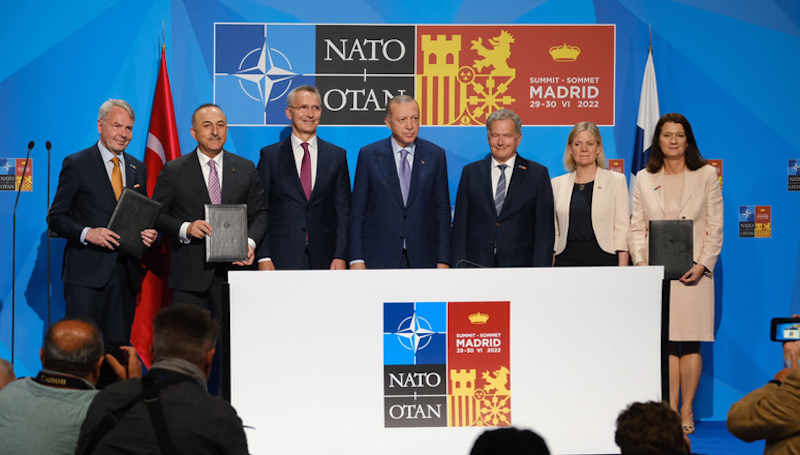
[{"left": 649, "top": 220, "right": 694, "bottom": 280}]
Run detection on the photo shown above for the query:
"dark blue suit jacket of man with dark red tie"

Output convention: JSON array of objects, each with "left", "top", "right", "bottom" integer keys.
[{"left": 256, "top": 136, "right": 350, "bottom": 269}]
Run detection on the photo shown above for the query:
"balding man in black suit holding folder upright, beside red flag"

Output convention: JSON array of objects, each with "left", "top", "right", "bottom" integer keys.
[{"left": 153, "top": 104, "right": 266, "bottom": 310}]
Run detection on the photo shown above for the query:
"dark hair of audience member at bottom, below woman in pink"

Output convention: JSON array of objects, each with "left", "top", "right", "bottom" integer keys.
[{"left": 614, "top": 401, "right": 689, "bottom": 455}]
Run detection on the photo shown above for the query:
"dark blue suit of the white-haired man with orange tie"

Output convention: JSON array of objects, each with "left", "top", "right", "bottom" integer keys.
[{"left": 48, "top": 144, "right": 147, "bottom": 344}]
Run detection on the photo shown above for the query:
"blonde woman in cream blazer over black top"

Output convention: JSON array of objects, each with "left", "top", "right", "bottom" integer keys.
[{"left": 551, "top": 122, "right": 630, "bottom": 266}]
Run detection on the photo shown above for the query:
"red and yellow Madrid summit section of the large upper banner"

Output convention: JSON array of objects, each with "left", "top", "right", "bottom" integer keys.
[{"left": 417, "top": 25, "right": 615, "bottom": 126}]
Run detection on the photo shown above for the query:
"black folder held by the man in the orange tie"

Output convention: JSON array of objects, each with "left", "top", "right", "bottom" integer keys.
[{"left": 108, "top": 188, "right": 161, "bottom": 259}]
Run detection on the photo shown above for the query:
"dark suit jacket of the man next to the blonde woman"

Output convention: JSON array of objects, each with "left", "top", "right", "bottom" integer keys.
[{"left": 453, "top": 155, "right": 555, "bottom": 267}]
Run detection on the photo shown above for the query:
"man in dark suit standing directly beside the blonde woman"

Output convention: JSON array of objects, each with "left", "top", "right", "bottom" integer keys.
[{"left": 453, "top": 109, "right": 555, "bottom": 267}]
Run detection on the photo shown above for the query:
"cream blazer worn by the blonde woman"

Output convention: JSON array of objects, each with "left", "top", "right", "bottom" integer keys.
[{"left": 551, "top": 168, "right": 630, "bottom": 254}]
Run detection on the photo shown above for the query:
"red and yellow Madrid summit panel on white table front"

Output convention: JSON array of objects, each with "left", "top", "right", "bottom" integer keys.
[{"left": 447, "top": 302, "right": 511, "bottom": 426}]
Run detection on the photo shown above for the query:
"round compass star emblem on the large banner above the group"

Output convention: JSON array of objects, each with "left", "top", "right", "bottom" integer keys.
[{"left": 230, "top": 37, "right": 298, "bottom": 108}]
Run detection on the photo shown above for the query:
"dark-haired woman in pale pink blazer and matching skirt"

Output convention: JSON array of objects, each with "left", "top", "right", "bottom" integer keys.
[{"left": 628, "top": 114, "right": 722, "bottom": 434}]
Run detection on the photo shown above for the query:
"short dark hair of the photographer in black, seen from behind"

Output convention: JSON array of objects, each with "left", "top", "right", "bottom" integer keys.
[{"left": 153, "top": 303, "right": 219, "bottom": 367}]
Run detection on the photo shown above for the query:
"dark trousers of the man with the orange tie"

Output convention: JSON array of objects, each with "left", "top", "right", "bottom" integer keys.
[{"left": 64, "top": 261, "right": 136, "bottom": 345}]
